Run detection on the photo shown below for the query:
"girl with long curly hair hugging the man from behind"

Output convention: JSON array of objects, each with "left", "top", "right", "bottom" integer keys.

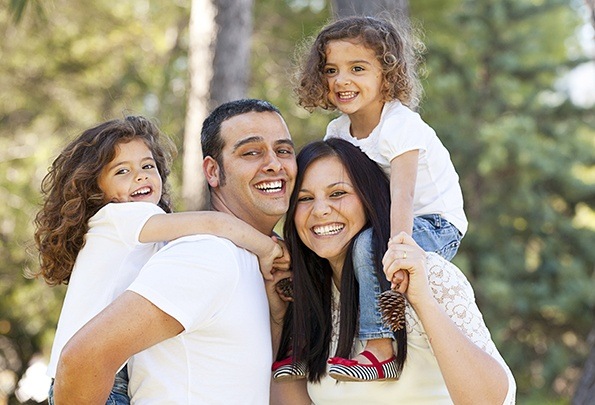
[{"left": 35, "top": 116, "right": 283, "bottom": 404}]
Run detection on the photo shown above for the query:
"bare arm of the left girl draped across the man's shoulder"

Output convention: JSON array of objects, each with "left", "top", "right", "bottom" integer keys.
[{"left": 139, "top": 211, "right": 283, "bottom": 279}]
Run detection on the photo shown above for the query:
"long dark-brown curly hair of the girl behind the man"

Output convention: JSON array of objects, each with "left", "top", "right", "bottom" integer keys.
[{"left": 33, "top": 116, "right": 176, "bottom": 285}]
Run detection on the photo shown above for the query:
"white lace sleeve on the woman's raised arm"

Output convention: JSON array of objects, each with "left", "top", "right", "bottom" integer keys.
[{"left": 427, "top": 253, "right": 516, "bottom": 405}]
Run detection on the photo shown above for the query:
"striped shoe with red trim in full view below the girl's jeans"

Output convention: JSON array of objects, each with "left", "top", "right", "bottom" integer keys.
[{"left": 328, "top": 350, "right": 398, "bottom": 381}]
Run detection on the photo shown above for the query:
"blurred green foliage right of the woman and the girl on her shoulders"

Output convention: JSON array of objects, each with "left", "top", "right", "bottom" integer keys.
[{"left": 412, "top": 0, "right": 595, "bottom": 398}]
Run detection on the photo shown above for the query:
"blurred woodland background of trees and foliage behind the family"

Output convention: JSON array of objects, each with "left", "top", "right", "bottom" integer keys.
[{"left": 0, "top": 0, "right": 595, "bottom": 404}]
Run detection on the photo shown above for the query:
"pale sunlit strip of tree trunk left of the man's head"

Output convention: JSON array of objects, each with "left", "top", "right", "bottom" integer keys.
[{"left": 182, "top": 0, "right": 216, "bottom": 210}]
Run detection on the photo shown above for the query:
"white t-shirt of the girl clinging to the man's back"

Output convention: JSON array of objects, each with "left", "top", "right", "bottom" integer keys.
[{"left": 47, "top": 202, "right": 164, "bottom": 378}]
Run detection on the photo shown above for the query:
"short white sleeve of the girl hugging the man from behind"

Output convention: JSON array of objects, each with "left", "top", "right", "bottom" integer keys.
[{"left": 102, "top": 202, "right": 165, "bottom": 246}]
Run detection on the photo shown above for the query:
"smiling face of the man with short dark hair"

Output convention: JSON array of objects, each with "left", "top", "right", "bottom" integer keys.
[{"left": 205, "top": 112, "right": 297, "bottom": 234}]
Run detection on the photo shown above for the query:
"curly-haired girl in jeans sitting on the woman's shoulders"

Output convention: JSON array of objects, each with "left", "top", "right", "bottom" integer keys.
[{"left": 274, "top": 17, "right": 467, "bottom": 381}]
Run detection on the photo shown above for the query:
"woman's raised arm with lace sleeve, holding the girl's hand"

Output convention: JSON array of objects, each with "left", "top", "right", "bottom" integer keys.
[{"left": 385, "top": 233, "right": 514, "bottom": 405}]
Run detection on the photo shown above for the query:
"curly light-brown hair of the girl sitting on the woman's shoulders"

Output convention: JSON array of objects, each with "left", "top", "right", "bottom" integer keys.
[{"left": 294, "top": 16, "right": 424, "bottom": 112}]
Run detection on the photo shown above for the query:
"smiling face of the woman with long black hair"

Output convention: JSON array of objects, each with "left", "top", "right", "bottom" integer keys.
[{"left": 294, "top": 156, "right": 367, "bottom": 270}]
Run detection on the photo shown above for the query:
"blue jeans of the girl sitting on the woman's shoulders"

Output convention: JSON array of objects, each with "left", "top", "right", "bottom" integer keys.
[{"left": 353, "top": 214, "right": 462, "bottom": 340}]
